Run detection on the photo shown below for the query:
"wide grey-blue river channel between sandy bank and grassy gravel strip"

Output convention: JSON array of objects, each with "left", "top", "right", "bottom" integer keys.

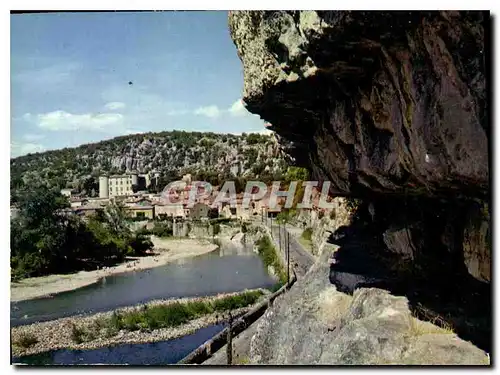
[{"left": 10, "top": 244, "right": 275, "bottom": 326}]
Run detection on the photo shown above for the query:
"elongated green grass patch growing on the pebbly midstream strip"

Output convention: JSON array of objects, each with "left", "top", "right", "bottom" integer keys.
[{"left": 71, "top": 290, "right": 264, "bottom": 344}]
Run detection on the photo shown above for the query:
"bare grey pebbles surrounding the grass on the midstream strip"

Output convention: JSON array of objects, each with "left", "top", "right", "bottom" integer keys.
[{"left": 11, "top": 289, "right": 269, "bottom": 357}]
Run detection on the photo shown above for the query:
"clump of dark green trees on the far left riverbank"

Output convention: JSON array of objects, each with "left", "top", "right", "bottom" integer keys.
[{"left": 10, "top": 187, "right": 153, "bottom": 281}]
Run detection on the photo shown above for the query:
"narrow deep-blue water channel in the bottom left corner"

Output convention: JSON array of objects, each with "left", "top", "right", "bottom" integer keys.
[{"left": 12, "top": 324, "right": 224, "bottom": 366}]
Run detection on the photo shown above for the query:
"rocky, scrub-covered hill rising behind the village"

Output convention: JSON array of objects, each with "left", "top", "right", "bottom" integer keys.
[{"left": 10, "top": 131, "right": 285, "bottom": 198}]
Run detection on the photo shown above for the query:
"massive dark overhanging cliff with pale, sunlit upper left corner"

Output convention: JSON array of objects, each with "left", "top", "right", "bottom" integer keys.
[{"left": 229, "top": 11, "right": 489, "bottom": 200}]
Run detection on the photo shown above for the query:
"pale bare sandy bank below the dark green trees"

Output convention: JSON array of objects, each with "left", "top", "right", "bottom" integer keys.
[{"left": 10, "top": 236, "right": 218, "bottom": 301}]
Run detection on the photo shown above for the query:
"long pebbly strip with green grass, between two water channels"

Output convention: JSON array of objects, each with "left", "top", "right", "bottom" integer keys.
[{"left": 12, "top": 289, "right": 269, "bottom": 356}]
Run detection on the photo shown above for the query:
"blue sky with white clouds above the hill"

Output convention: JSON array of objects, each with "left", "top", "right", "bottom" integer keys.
[{"left": 11, "top": 11, "right": 264, "bottom": 156}]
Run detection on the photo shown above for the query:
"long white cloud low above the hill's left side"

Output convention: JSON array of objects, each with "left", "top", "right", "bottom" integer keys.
[{"left": 33, "top": 110, "right": 123, "bottom": 131}]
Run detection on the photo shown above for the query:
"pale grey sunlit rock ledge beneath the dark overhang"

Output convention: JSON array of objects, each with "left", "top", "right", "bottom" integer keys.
[{"left": 250, "top": 248, "right": 489, "bottom": 365}]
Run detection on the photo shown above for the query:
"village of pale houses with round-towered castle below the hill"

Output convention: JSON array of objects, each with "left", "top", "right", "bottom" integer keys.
[{"left": 11, "top": 173, "right": 336, "bottom": 226}]
